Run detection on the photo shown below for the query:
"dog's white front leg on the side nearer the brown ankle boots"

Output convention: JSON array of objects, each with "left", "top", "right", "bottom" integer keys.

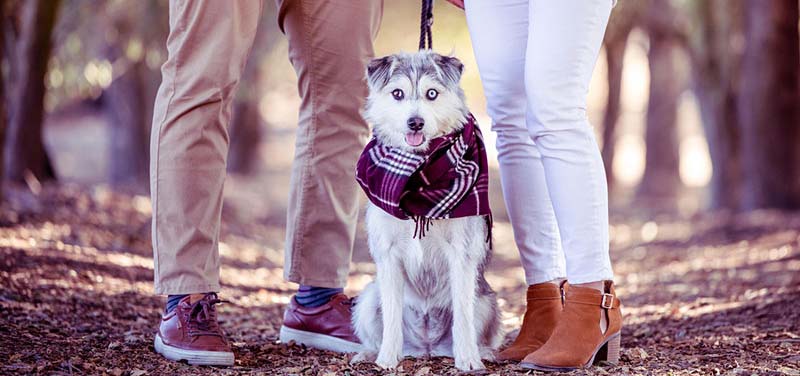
[{"left": 448, "top": 242, "right": 484, "bottom": 371}]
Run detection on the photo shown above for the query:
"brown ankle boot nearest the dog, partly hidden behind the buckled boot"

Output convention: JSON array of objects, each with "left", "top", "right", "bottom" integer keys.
[{"left": 497, "top": 281, "right": 567, "bottom": 361}]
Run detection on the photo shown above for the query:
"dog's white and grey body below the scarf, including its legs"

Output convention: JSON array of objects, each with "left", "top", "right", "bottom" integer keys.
[{"left": 353, "top": 204, "right": 502, "bottom": 369}]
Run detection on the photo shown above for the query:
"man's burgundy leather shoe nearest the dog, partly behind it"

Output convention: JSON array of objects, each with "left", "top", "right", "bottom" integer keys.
[{"left": 280, "top": 294, "right": 361, "bottom": 353}]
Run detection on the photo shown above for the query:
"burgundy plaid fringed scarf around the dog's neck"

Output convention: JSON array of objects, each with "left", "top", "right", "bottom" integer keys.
[{"left": 356, "top": 115, "right": 492, "bottom": 242}]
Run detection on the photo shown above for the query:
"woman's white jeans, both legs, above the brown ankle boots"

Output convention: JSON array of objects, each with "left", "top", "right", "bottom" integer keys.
[{"left": 466, "top": 0, "right": 613, "bottom": 284}]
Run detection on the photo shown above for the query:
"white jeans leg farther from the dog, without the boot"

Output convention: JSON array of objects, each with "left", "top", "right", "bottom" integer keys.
[{"left": 524, "top": 0, "right": 613, "bottom": 286}]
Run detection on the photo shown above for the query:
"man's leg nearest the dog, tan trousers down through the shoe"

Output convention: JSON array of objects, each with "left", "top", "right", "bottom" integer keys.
[{"left": 277, "top": 0, "right": 383, "bottom": 350}]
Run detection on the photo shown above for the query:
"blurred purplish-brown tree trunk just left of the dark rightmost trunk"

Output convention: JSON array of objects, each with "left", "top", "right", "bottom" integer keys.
[{"left": 685, "top": 0, "right": 743, "bottom": 210}]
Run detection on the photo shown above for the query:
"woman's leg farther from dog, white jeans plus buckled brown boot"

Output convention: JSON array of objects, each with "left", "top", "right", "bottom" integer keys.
[{"left": 521, "top": 4, "right": 622, "bottom": 371}]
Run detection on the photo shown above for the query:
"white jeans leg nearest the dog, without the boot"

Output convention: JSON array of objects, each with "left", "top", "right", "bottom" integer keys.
[{"left": 465, "top": 0, "right": 566, "bottom": 285}]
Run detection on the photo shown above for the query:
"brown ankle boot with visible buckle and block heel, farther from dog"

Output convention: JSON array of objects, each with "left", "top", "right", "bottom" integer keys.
[{"left": 521, "top": 281, "right": 622, "bottom": 372}]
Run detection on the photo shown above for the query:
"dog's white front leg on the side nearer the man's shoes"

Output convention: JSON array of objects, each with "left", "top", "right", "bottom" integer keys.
[{"left": 375, "top": 258, "right": 405, "bottom": 368}]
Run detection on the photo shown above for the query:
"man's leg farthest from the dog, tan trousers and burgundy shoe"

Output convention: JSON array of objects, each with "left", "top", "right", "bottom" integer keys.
[{"left": 150, "top": 0, "right": 262, "bottom": 364}]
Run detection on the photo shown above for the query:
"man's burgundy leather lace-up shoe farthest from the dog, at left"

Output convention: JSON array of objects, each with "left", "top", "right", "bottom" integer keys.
[{"left": 154, "top": 293, "right": 233, "bottom": 366}]
